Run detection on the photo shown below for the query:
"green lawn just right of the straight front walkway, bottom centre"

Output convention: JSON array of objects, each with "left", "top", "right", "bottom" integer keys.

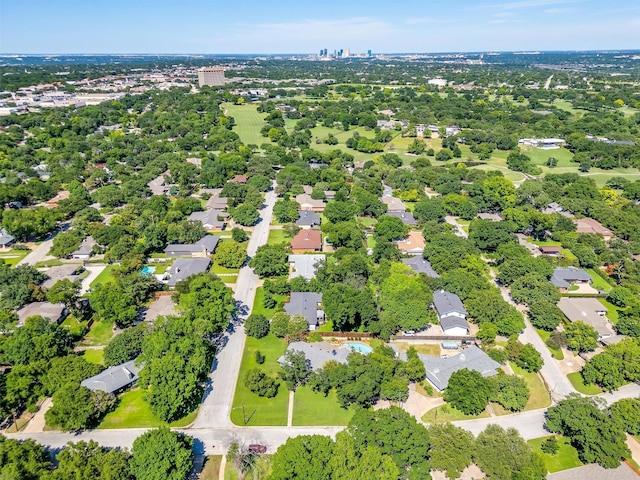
[{"left": 293, "top": 386, "right": 356, "bottom": 426}]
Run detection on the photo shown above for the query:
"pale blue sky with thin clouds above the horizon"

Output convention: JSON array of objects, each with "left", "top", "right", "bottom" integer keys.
[{"left": 0, "top": 0, "right": 640, "bottom": 54}]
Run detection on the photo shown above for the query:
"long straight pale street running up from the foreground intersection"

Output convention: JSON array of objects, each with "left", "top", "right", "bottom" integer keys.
[{"left": 193, "top": 186, "right": 276, "bottom": 428}]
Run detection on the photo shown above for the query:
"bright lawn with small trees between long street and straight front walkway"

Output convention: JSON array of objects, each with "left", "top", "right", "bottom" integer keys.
[{"left": 231, "top": 335, "right": 289, "bottom": 427}]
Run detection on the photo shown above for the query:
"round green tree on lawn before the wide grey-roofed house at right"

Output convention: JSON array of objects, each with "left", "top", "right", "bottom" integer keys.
[{"left": 444, "top": 368, "right": 491, "bottom": 415}]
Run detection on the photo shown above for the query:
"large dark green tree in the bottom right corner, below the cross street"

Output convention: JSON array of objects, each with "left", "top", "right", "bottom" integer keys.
[{"left": 545, "top": 394, "right": 630, "bottom": 468}]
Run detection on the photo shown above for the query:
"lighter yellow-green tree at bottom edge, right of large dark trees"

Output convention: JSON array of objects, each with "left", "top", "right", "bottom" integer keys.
[{"left": 429, "top": 423, "right": 474, "bottom": 479}]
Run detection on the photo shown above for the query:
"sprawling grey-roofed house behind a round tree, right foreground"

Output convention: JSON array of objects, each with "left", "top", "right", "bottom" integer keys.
[{"left": 418, "top": 345, "right": 500, "bottom": 392}]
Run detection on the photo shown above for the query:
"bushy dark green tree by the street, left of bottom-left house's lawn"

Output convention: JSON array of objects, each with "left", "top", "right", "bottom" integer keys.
[{"left": 45, "top": 383, "right": 115, "bottom": 431}]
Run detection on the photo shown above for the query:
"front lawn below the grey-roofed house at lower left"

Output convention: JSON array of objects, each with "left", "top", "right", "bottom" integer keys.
[{"left": 98, "top": 388, "right": 198, "bottom": 428}]
